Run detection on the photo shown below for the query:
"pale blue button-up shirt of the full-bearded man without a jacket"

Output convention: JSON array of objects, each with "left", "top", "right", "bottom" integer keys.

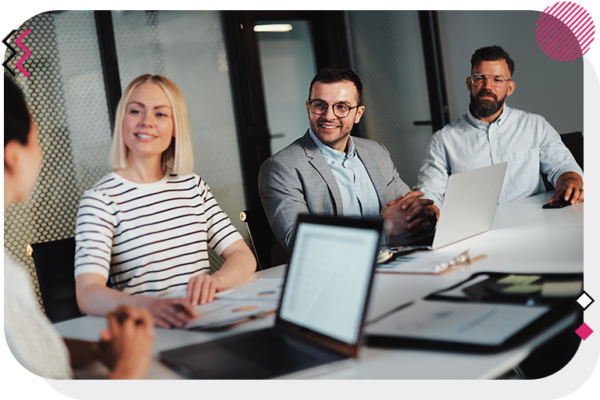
[{"left": 417, "top": 103, "right": 583, "bottom": 208}]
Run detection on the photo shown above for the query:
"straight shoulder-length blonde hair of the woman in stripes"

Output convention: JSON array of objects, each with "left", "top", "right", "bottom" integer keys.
[{"left": 110, "top": 74, "right": 194, "bottom": 175}]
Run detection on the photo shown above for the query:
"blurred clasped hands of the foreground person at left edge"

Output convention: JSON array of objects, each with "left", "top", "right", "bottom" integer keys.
[{"left": 97, "top": 306, "right": 154, "bottom": 379}]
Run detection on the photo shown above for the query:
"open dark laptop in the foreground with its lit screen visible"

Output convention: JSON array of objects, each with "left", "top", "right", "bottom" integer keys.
[{"left": 160, "top": 215, "right": 382, "bottom": 379}]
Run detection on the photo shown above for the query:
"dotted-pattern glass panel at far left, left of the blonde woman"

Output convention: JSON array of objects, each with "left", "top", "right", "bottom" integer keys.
[{"left": 2, "top": 10, "right": 112, "bottom": 306}]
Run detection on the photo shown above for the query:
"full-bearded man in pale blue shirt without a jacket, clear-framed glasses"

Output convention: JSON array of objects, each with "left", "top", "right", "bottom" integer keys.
[{"left": 417, "top": 46, "right": 583, "bottom": 216}]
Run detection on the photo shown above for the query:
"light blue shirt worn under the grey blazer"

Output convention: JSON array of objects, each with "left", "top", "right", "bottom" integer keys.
[{"left": 308, "top": 128, "right": 379, "bottom": 218}]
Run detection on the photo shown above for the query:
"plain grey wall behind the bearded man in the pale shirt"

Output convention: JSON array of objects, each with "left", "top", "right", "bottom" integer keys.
[{"left": 438, "top": 9, "right": 583, "bottom": 133}]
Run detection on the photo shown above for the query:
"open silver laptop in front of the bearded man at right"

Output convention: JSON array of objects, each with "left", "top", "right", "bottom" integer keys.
[{"left": 387, "top": 162, "right": 508, "bottom": 254}]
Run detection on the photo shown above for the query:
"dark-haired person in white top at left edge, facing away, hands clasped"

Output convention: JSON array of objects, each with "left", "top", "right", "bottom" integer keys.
[{"left": 2, "top": 75, "right": 154, "bottom": 379}]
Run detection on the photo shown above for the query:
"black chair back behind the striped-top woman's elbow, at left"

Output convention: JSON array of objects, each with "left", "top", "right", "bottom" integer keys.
[{"left": 27, "top": 238, "right": 83, "bottom": 323}]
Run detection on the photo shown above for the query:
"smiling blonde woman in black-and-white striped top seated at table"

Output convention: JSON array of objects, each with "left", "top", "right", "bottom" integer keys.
[{"left": 75, "top": 75, "right": 256, "bottom": 328}]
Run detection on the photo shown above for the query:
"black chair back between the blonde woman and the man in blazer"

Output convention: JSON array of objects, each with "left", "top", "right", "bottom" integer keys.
[{"left": 240, "top": 210, "right": 289, "bottom": 270}]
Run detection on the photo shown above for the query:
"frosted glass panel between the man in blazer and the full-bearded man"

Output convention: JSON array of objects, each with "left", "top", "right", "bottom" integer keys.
[{"left": 345, "top": 11, "right": 432, "bottom": 187}]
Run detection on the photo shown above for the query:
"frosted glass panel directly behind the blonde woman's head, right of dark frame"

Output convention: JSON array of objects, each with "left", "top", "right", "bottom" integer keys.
[{"left": 112, "top": 11, "right": 247, "bottom": 265}]
